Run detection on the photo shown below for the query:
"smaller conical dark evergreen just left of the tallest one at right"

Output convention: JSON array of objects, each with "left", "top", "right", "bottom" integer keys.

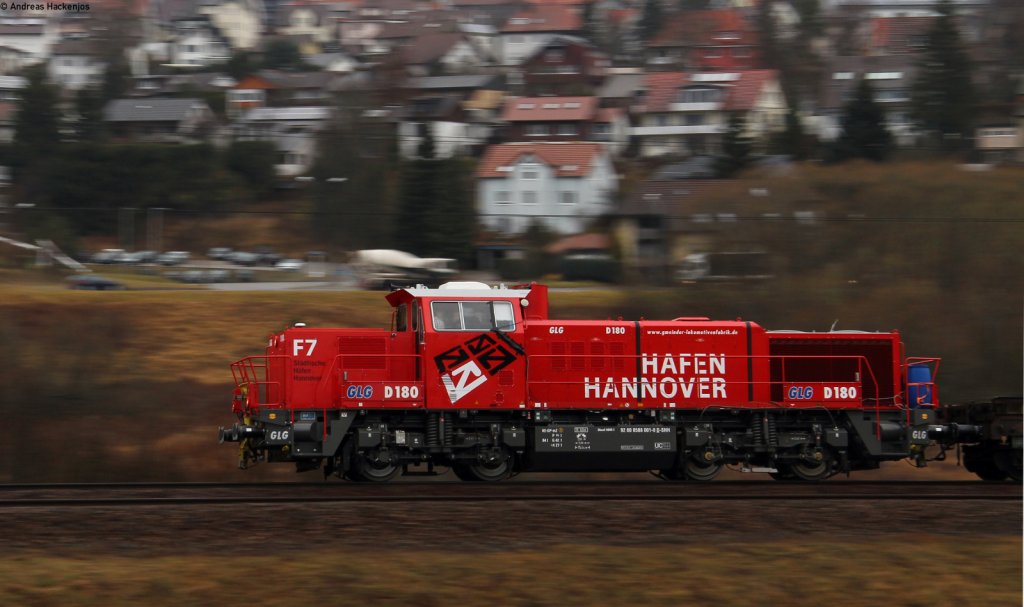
[{"left": 831, "top": 78, "right": 893, "bottom": 162}]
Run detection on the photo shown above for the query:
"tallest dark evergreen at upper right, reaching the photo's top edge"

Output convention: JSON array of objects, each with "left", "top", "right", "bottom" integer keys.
[{"left": 911, "top": 0, "right": 975, "bottom": 150}]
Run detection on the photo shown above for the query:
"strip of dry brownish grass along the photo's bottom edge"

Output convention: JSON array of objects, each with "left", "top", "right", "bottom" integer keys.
[{"left": 0, "top": 529, "right": 1021, "bottom": 607}]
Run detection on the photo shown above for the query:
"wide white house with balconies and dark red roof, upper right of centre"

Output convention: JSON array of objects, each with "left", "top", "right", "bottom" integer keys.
[{"left": 632, "top": 70, "right": 787, "bottom": 157}]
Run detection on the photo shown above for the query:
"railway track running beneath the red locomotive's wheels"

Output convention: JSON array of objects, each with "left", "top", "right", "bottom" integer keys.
[{"left": 0, "top": 481, "right": 1022, "bottom": 508}]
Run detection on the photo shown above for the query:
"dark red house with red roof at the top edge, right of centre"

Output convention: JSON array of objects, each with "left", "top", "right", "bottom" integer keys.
[{"left": 647, "top": 9, "right": 761, "bottom": 72}]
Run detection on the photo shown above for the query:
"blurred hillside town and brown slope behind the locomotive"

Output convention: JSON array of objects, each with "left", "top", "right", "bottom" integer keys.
[{"left": 0, "top": 0, "right": 1024, "bottom": 482}]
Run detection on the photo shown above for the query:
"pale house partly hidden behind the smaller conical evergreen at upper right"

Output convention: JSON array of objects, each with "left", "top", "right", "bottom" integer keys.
[{"left": 812, "top": 54, "right": 919, "bottom": 146}]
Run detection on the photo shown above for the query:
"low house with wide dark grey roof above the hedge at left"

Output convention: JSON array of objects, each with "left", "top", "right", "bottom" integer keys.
[{"left": 103, "top": 97, "right": 214, "bottom": 143}]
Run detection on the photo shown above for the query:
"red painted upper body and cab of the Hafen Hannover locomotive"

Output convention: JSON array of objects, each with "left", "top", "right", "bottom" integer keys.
[{"left": 233, "top": 287, "right": 929, "bottom": 410}]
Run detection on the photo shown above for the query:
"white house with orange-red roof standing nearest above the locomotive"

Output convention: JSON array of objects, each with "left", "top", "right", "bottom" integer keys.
[{"left": 476, "top": 141, "right": 618, "bottom": 234}]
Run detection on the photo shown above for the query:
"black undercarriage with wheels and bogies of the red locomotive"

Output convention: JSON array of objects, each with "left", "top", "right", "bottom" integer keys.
[{"left": 222, "top": 407, "right": 954, "bottom": 481}]
